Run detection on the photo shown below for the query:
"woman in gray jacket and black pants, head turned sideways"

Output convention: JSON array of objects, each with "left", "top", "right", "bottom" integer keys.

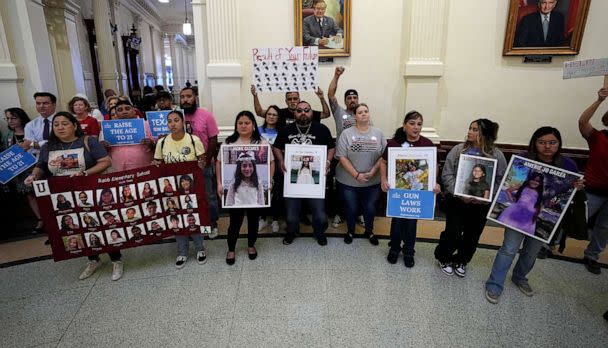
[{"left": 435, "top": 118, "right": 507, "bottom": 277}]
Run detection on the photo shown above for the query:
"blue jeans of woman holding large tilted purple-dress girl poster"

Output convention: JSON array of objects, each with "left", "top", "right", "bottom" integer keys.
[{"left": 486, "top": 228, "right": 544, "bottom": 295}]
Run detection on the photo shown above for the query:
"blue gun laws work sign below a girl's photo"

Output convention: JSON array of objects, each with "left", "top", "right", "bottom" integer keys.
[{"left": 386, "top": 189, "right": 435, "bottom": 220}]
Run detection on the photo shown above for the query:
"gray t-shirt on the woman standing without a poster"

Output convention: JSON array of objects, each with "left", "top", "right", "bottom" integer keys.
[{"left": 336, "top": 126, "right": 386, "bottom": 187}]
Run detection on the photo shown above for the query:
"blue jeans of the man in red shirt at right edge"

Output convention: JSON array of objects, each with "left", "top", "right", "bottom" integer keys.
[{"left": 585, "top": 191, "right": 608, "bottom": 261}]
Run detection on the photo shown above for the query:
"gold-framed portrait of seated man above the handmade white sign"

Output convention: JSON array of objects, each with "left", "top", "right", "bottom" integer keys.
[{"left": 294, "top": 0, "right": 351, "bottom": 57}]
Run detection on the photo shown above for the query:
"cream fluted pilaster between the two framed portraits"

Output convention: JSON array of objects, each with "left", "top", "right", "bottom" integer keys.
[{"left": 398, "top": 0, "right": 449, "bottom": 142}]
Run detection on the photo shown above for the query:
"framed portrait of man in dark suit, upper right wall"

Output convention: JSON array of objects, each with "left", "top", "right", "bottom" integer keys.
[{"left": 503, "top": 0, "right": 591, "bottom": 56}]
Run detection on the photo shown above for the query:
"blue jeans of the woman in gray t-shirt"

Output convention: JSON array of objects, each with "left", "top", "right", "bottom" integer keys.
[{"left": 339, "top": 183, "right": 380, "bottom": 234}]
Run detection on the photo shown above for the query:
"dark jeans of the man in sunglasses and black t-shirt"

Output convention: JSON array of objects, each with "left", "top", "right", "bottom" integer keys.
[{"left": 285, "top": 197, "right": 327, "bottom": 238}]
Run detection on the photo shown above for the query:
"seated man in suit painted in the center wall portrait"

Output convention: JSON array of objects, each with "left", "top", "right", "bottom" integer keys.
[{"left": 303, "top": 0, "right": 344, "bottom": 46}]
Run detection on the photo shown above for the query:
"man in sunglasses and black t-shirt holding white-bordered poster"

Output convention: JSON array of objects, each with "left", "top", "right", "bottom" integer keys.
[{"left": 273, "top": 101, "right": 336, "bottom": 245}]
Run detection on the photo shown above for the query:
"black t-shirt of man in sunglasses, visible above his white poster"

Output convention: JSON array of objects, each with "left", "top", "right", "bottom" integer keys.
[{"left": 273, "top": 122, "right": 336, "bottom": 150}]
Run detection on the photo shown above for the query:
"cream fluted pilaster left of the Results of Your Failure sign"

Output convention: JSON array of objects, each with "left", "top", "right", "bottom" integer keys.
[{"left": 200, "top": 0, "right": 243, "bottom": 126}]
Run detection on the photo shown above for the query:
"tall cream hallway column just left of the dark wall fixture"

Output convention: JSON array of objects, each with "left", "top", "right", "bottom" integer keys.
[{"left": 92, "top": 0, "right": 124, "bottom": 92}]
